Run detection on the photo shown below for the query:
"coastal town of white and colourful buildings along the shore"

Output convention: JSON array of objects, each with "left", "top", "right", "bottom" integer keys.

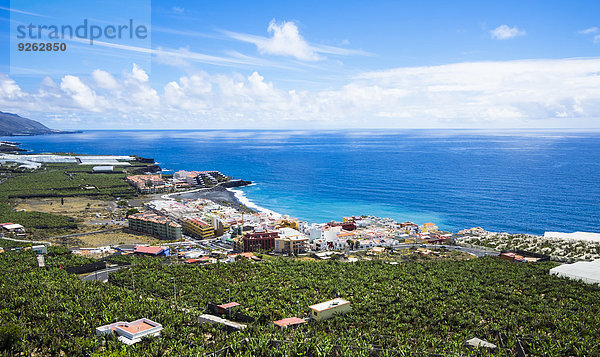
[{"left": 0, "top": 150, "right": 600, "bottom": 264}]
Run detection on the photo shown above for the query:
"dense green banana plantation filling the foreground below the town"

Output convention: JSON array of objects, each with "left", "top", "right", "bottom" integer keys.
[{"left": 0, "top": 252, "right": 600, "bottom": 356}]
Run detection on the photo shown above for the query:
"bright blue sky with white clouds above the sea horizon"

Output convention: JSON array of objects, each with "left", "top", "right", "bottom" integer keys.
[{"left": 0, "top": 0, "right": 600, "bottom": 129}]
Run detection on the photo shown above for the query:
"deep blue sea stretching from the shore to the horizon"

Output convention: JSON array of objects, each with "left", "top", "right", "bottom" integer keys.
[{"left": 0, "top": 130, "right": 600, "bottom": 234}]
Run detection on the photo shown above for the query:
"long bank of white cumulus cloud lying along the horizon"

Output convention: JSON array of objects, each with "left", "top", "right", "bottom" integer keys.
[{"left": 0, "top": 58, "right": 600, "bottom": 128}]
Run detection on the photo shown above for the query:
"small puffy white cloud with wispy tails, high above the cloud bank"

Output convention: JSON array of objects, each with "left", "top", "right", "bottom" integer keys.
[{"left": 224, "top": 20, "right": 369, "bottom": 61}]
